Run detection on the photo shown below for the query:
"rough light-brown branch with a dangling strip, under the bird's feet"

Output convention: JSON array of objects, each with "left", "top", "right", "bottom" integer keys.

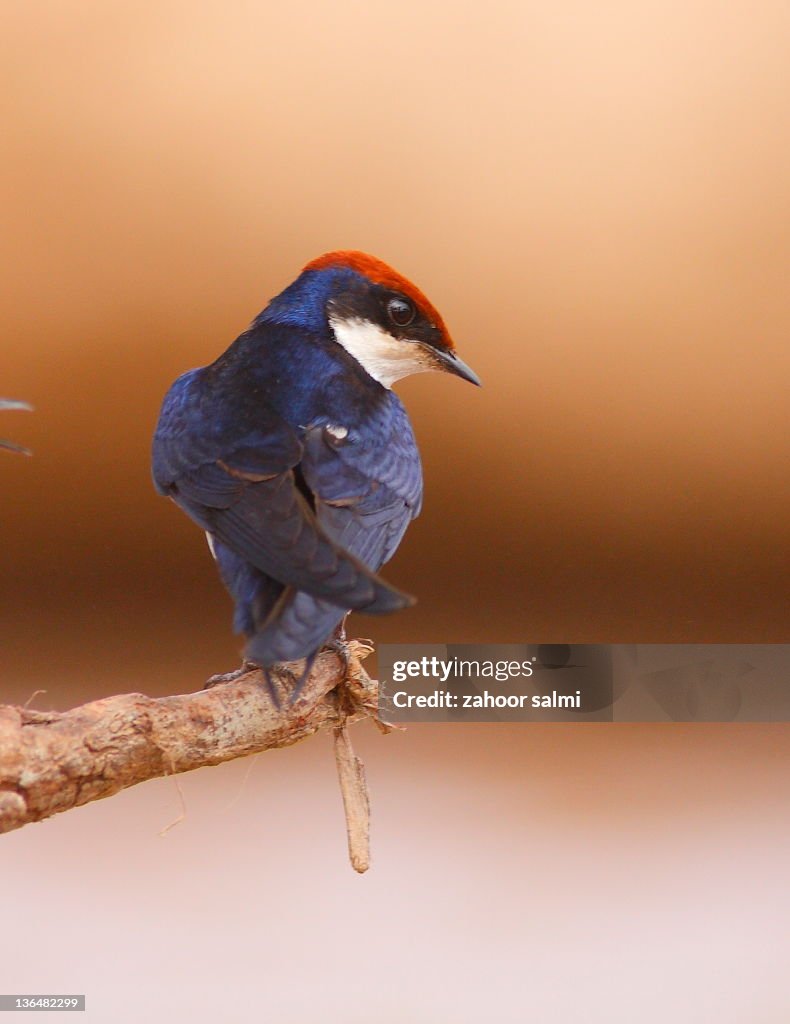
[{"left": 0, "top": 640, "right": 377, "bottom": 870}]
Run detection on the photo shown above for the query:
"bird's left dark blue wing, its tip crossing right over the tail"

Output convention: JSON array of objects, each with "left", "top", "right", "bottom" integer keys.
[{"left": 153, "top": 370, "right": 418, "bottom": 612}]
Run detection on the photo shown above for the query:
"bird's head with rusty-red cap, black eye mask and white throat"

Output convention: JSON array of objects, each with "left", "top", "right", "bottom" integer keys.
[{"left": 264, "top": 251, "right": 481, "bottom": 388}]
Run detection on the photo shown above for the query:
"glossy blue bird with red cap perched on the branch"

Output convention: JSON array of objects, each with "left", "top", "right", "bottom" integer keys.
[{"left": 152, "top": 250, "right": 481, "bottom": 698}]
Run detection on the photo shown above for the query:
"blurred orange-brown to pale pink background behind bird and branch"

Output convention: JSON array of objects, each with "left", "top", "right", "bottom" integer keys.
[{"left": 0, "top": 0, "right": 790, "bottom": 1024}]
